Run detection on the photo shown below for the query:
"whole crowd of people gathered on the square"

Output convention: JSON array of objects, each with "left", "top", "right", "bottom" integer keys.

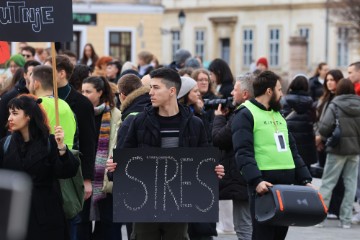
[{"left": 0, "top": 43, "right": 360, "bottom": 240}]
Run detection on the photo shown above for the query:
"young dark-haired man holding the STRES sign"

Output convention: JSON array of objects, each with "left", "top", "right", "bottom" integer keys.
[{"left": 107, "top": 68, "right": 224, "bottom": 240}]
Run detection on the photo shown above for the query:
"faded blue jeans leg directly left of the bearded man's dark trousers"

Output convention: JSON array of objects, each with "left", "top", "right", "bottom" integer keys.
[{"left": 233, "top": 200, "right": 252, "bottom": 240}]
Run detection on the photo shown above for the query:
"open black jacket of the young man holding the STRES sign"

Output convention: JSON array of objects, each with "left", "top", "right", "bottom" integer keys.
[{"left": 123, "top": 104, "right": 208, "bottom": 148}]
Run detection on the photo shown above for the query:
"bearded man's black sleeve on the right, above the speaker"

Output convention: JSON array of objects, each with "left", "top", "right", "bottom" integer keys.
[{"left": 289, "top": 132, "right": 312, "bottom": 184}]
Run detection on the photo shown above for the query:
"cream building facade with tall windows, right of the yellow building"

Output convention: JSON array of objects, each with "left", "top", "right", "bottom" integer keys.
[{"left": 162, "top": 0, "right": 359, "bottom": 75}]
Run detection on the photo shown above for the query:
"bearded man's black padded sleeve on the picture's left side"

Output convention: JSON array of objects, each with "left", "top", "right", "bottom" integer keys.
[{"left": 231, "top": 107, "right": 262, "bottom": 186}]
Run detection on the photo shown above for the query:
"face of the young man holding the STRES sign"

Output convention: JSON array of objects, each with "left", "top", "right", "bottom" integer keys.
[{"left": 149, "top": 78, "right": 176, "bottom": 107}]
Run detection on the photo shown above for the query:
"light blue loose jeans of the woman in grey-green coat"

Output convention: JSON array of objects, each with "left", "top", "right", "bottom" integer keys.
[{"left": 320, "top": 153, "right": 359, "bottom": 224}]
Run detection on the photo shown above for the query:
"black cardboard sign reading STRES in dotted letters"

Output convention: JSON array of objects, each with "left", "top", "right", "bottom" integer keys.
[{"left": 113, "top": 148, "right": 219, "bottom": 222}]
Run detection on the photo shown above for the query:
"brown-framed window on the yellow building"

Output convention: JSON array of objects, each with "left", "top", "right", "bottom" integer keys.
[{"left": 109, "top": 32, "right": 131, "bottom": 62}]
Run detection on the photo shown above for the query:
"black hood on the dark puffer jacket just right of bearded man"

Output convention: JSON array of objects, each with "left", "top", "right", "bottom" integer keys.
[{"left": 282, "top": 92, "right": 313, "bottom": 114}]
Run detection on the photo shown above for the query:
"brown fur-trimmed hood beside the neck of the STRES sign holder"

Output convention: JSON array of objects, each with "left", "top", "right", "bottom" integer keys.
[{"left": 120, "top": 87, "right": 150, "bottom": 120}]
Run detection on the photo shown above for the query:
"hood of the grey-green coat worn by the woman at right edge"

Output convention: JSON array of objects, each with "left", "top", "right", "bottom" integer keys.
[{"left": 331, "top": 94, "right": 360, "bottom": 116}]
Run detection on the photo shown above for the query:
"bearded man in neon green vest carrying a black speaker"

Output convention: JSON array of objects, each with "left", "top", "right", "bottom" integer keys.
[{"left": 231, "top": 71, "right": 312, "bottom": 240}]
